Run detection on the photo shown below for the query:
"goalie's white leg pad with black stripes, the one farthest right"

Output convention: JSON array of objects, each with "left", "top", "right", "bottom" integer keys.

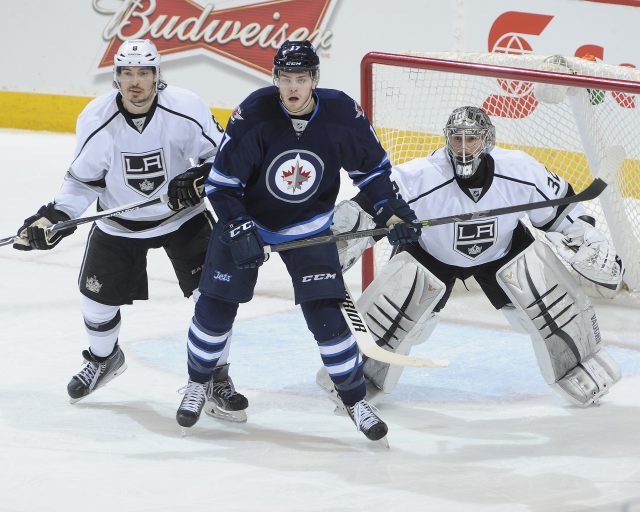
[{"left": 496, "top": 241, "right": 620, "bottom": 406}]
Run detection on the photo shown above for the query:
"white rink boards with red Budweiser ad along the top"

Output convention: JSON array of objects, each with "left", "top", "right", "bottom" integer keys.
[{"left": 0, "top": 0, "right": 640, "bottom": 108}]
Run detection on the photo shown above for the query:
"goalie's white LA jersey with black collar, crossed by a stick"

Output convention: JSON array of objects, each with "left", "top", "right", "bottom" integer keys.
[{"left": 391, "top": 148, "right": 584, "bottom": 267}]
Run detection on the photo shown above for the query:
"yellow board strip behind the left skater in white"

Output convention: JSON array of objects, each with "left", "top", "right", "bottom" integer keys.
[{"left": 0, "top": 91, "right": 232, "bottom": 133}]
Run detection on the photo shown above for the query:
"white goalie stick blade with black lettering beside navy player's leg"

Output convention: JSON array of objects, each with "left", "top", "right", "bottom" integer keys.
[{"left": 340, "top": 284, "right": 449, "bottom": 368}]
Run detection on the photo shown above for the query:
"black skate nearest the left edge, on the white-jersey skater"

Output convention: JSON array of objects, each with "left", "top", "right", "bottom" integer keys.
[{"left": 67, "top": 343, "right": 127, "bottom": 404}]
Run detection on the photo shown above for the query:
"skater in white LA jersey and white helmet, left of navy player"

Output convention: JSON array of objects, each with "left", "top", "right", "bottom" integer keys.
[{"left": 14, "top": 40, "right": 228, "bottom": 402}]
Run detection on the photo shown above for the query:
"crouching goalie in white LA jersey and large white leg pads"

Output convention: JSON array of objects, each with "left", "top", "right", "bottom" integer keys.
[{"left": 318, "top": 107, "right": 623, "bottom": 406}]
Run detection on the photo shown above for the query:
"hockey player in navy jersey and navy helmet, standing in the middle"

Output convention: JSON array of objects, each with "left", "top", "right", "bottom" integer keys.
[{"left": 170, "top": 41, "right": 420, "bottom": 440}]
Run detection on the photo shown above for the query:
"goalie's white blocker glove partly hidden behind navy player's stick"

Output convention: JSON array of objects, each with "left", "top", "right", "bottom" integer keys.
[{"left": 331, "top": 200, "right": 376, "bottom": 272}]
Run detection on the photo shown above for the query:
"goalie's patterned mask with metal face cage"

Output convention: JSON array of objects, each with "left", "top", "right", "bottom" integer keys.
[{"left": 444, "top": 107, "right": 496, "bottom": 179}]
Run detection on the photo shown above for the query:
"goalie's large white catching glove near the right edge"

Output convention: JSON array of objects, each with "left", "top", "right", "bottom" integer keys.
[{"left": 546, "top": 219, "right": 624, "bottom": 290}]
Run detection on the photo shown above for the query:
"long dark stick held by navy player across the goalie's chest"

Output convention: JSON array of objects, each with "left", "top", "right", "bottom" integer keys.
[{"left": 264, "top": 178, "right": 607, "bottom": 254}]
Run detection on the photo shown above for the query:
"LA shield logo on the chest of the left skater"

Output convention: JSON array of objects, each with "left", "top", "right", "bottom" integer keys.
[{"left": 122, "top": 148, "right": 167, "bottom": 197}]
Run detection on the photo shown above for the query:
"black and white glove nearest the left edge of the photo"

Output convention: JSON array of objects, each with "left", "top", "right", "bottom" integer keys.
[{"left": 13, "top": 203, "right": 76, "bottom": 251}]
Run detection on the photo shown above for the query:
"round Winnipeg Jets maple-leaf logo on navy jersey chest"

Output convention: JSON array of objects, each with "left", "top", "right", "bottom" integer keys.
[{"left": 266, "top": 149, "right": 324, "bottom": 203}]
